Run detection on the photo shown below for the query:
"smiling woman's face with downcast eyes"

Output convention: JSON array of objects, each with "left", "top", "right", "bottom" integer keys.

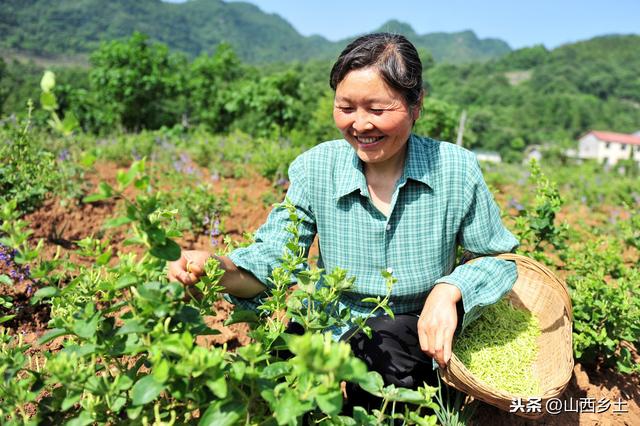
[{"left": 333, "top": 68, "right": 420, "bottom": 165}]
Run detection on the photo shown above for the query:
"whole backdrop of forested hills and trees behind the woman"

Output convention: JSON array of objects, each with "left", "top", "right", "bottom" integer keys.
[{"left": 0, "top": 0, "right": 640, "bottom": 161}]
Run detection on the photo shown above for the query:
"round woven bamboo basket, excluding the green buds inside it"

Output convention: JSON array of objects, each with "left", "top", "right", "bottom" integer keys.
[{"left": 441, "top": 253, "right": 573, "bottom": 419}]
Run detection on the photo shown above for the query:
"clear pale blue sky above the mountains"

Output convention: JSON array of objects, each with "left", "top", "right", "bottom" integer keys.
[{"left": 165, "top": 0, "right": 640, "bottom": 49}]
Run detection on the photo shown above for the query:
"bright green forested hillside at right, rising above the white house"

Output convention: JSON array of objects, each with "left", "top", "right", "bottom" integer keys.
[{"left": 425, "top": 35, "right": 640, "bottom": 158}]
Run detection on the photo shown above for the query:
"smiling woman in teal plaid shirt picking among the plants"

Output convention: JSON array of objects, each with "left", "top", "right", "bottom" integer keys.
[{"left": 169, "top": 33, "right": 518, "bottom": 412}]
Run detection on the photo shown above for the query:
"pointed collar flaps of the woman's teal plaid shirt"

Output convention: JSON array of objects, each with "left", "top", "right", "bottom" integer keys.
[{"left": 335, "top": 134, "right": 433, "bottom": 199}]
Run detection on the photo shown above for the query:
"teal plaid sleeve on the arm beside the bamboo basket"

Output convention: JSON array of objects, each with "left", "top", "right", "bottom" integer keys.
[{"left": 436, "top": 158, "right": 519, "bottom": 329}]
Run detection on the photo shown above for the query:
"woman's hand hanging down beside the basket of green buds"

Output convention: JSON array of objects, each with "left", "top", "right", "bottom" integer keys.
[{"left": 418, "top": 283, "right": 462, "bottom": 368}]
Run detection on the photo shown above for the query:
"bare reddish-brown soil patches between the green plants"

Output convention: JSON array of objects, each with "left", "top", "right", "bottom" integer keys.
[{"left": 0, "top": 164, "right": 640, "bottom": 425}]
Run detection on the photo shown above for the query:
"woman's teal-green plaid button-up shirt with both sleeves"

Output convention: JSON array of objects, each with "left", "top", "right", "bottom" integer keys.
[{"left": 228, "top": 135, "right": 518, "bottom": 337}]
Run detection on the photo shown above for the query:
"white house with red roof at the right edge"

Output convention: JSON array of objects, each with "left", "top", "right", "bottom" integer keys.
[{"left": 577, "top": 130, "right": 640, "bottom": 166}]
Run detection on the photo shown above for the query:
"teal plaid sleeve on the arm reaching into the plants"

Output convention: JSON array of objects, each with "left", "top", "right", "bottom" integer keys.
[{"left": 225, "top": 156, "right": 316, "bottom": 310}]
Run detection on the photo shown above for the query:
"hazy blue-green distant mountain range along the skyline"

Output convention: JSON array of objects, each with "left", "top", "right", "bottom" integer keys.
[{"left": 0, "top": 0, "right": 511, "bottom": 63}]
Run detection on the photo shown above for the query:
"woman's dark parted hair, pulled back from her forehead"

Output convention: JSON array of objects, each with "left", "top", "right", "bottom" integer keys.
[{"left": 329, "top": 33, "right": 422, "bottom": 107}]
